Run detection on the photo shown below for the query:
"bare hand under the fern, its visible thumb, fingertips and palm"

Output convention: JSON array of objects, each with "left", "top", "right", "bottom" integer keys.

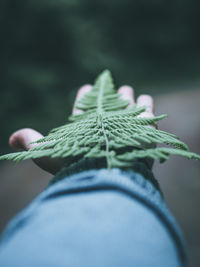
[{"left": 9, "top": 85, "right": 154, "bottom": 174}]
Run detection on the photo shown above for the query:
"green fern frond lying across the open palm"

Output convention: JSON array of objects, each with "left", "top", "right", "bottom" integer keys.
[{"left": 0, "top": 71, "right": 200, "bottom": 169}]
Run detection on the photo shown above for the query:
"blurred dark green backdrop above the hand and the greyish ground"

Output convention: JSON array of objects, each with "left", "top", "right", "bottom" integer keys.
[{"left": 0, "top": 0, "right": 200, "bottom": 154}]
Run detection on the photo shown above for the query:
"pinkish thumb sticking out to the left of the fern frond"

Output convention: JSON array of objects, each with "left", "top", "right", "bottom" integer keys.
[{"left": 9, "top": 128, "right": 43, "bottom": 151}]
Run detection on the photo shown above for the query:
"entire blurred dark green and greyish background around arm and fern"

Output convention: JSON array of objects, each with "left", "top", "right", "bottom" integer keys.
[{"left": 0, "top": 0, "right": 200, "bottom": 267}]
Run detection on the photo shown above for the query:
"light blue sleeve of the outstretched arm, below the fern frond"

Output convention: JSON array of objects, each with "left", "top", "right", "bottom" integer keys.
[{"left": 0, "top": 169, "right": 185, "bottom": 267}]
